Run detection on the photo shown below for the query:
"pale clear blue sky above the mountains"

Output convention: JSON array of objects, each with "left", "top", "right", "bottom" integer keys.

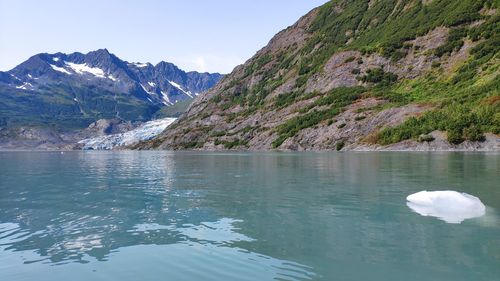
[{"left": 0, "top": 0, "right": 327, "bottom": 73}]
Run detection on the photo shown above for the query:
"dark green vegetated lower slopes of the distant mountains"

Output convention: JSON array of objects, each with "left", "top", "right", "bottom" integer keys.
[{"left": 0, "top": 84, "right": 157, "bottom": 129}]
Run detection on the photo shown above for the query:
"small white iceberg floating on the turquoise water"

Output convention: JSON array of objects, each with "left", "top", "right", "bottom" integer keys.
[{"left": 406, "top": 190, "right": 486, "bottom": 223}]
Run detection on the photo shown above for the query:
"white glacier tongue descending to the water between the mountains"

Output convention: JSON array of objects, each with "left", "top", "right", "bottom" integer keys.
[{"left": 78, "top": 118, "right": 176, "bottom": 150}]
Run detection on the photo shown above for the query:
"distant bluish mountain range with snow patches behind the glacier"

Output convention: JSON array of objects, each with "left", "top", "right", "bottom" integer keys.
[{"left": 0, "top": 49, "right": 222, "bottom": 128}]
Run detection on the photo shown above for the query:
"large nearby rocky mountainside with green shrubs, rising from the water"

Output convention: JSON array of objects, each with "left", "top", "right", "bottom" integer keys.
[{"left": 135, "top": 0, "right": 500, "bottom": 150}]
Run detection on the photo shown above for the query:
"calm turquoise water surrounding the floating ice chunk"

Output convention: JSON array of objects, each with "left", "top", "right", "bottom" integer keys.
[{"left": 0, "top": 152, "right": 500, "bottom": 281}]
